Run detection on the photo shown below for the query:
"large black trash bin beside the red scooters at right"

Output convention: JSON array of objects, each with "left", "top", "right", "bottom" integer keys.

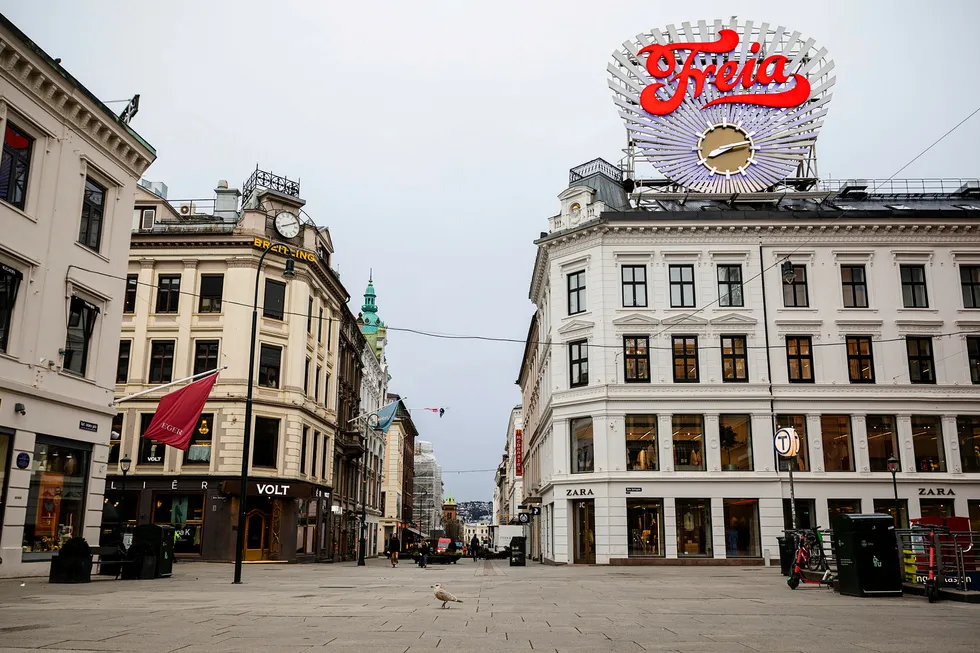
[{"left": 834, "top": 513, "right": 902, "bottom": 596}]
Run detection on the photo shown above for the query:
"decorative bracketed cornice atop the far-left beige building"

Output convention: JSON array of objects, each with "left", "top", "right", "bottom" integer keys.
[{"left": 0, "top": 34, "right": 156, "bottom": 174}]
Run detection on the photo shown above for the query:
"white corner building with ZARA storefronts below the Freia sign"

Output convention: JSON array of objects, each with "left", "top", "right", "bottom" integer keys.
[{"left": 524, "top": 166, "right": 980, "bottom": 564}]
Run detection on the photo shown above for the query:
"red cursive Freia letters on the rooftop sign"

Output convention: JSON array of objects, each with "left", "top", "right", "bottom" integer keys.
[{"left": 640, "top": 29, "right": 810, "bottom": 116}]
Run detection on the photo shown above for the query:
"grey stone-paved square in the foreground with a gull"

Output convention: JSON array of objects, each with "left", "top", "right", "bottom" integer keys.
[{"left": 0, "top": 559, "right": 980, "bottom": 653}]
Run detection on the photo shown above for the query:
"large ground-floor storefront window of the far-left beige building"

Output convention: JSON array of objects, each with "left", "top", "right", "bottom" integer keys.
[{"left": 23, "top": 436, "right": 92, "bottom": 561}]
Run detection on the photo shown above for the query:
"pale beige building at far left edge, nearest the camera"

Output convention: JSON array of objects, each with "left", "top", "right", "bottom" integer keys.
[{"left": 0, "top": 16, "right": 156, "bottom": 577}]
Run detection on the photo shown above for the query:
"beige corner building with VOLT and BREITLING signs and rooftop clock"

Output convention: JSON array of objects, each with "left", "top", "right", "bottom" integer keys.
[{"left": 102, "top": 170, "right": 356, "bottom": 560}]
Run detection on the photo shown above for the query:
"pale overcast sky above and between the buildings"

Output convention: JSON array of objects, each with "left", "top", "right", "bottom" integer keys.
[{"left": 9, "top": 0, "right": 980, "bottom": 500}]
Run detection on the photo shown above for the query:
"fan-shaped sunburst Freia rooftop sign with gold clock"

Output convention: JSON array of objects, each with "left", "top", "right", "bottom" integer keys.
[{"left": 608, "top": 19, "right": 834, "bottom": 193}]
